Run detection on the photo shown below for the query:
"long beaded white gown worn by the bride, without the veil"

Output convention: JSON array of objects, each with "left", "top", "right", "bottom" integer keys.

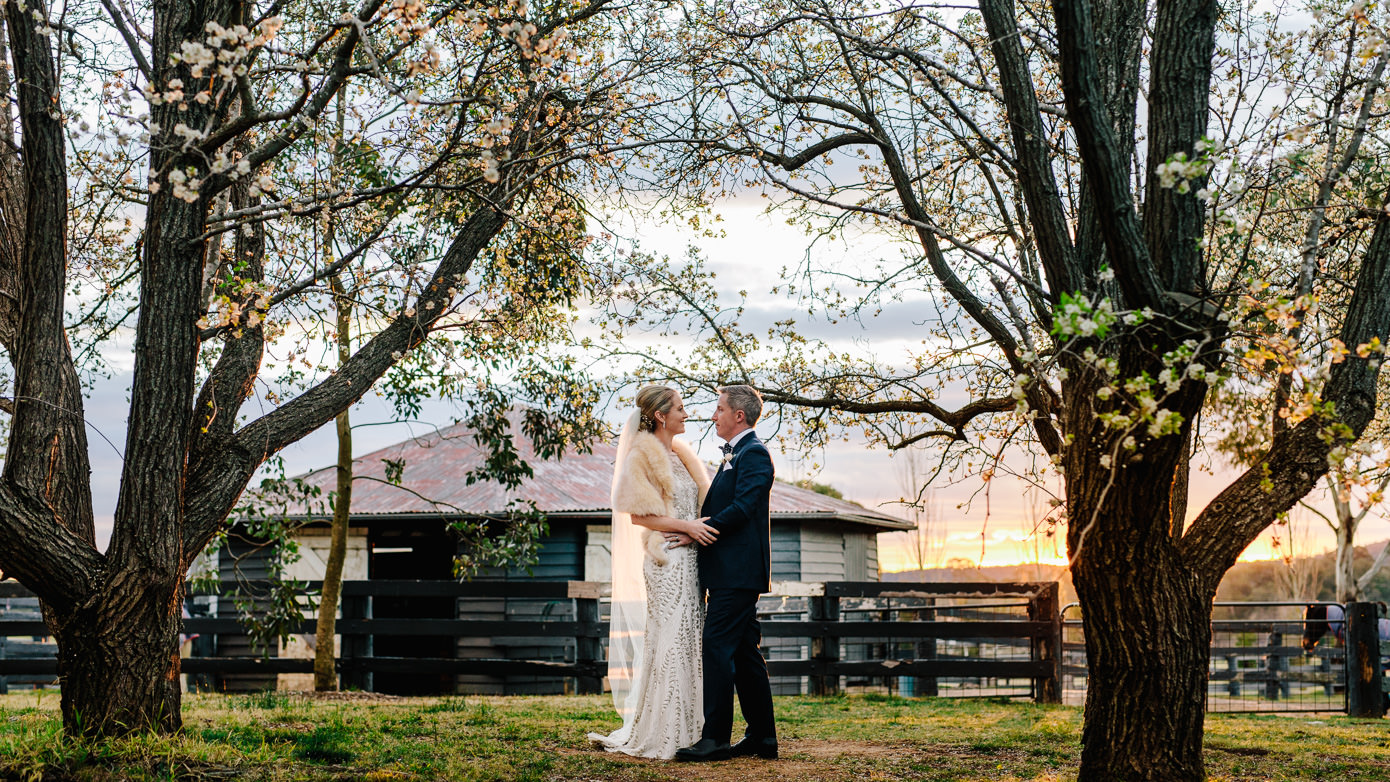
[{"left": 589, "top": 454, "right": 705, "bottom": 760}]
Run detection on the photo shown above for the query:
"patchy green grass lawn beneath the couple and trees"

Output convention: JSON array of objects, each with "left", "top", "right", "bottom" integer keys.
[{"left": 0, "top": 692, "right": 1390, "bottom": 782}]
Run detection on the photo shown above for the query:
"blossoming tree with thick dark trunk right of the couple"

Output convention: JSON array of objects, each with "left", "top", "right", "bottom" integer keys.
[{"left": 614, "top": 0, "right": 1390, "bottom": 781}]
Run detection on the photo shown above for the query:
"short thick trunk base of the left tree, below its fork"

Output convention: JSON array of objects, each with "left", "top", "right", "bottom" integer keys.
[{"left": 54, "top": 571, "right": 183, "bottom": 738}]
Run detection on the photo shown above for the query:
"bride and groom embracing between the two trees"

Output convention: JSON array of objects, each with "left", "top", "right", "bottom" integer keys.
[{"left": 589, "top": 386, "right": 777, "bottom": 761}]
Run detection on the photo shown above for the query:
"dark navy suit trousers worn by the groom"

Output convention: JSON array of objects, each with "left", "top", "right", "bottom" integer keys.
[{"left": 701, "top": 589, "right": 777, "bottom": 743}]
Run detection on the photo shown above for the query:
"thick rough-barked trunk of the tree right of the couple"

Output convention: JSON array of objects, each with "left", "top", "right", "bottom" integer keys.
[{"left": 1065, "top": 358, "right": 1215, "bottom": 782}]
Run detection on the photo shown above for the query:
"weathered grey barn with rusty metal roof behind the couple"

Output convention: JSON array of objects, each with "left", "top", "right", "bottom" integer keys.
[{"left": 224, "top": 424, "right": 912, "bottom": 694}]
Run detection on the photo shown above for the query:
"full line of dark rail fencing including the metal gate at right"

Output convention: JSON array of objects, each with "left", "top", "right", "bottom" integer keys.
[{"left": 8, "top": 581, "right": 1390, "bottom": 715}]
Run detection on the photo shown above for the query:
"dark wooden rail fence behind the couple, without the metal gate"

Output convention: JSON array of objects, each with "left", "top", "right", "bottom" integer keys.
[{"left": 0, "top": 581, "right": 1062, "bottom": 703}]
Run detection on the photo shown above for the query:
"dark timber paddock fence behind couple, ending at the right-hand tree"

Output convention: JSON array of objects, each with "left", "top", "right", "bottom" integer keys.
[{"left": 0, "top": 581, "right": 1062, "bottom": 703}]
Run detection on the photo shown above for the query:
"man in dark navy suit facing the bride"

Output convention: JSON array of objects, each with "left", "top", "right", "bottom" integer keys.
[{"left": 676, "top": 386, "right": 777, "bottom": 761}]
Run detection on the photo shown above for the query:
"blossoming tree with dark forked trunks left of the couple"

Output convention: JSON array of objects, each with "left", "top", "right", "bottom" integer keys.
[{"left": 0, "top": 0, "right": 669, "bottom": 736}]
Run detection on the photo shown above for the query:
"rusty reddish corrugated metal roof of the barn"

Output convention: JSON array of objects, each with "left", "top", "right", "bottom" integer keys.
[{"left": 303, "top": 424, "right": 912, "bottom": 529}]
